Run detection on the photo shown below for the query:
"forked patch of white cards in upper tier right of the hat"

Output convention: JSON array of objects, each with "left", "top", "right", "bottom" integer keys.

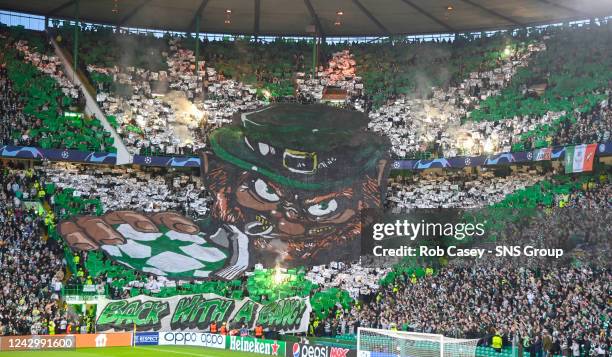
[{"left": 370, "top": 38, "right": 550, "bottom": 157}]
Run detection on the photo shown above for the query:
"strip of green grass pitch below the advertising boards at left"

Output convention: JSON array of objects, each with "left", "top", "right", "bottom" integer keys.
[{"left": 0, "top": 346, "right": 264, "bottom": 357}]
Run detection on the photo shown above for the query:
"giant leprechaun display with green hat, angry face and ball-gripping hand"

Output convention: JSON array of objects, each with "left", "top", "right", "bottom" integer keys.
[{"left": 60, "top": 104, "right": 389, "bottom": 279}]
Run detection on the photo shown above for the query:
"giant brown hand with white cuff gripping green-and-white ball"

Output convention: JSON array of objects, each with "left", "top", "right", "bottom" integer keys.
[{"left": 58, "top": 210, "right": 231, "bottom": 278}]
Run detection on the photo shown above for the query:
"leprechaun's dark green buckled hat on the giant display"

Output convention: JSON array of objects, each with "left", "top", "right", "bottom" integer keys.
[{"left": 210, "top": 104, "right": 390, "bottom": 190}]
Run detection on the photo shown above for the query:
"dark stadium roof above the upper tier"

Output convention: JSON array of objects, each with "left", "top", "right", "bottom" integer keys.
[{"left": 0, "top": 0, "right": 612, "bottom": 37}]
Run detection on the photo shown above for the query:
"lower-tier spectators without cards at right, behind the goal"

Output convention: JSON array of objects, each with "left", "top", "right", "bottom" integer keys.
[{"left": 313, "top": 174, "right": 612, "bottom": 356}]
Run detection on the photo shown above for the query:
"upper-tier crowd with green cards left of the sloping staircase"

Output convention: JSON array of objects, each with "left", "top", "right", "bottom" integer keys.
[{"left": 0, "top": 23, "right": 114, "bottom": 152}]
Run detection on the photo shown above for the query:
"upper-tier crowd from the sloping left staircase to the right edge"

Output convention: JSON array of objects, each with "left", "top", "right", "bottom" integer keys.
[{"left": 33, "top": 22, "right": 612, "bottom": 158}]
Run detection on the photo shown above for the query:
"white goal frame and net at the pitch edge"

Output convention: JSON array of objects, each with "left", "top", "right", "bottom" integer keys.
[{"left": 357, "top": 327, "right": 478, "bottom": 357}]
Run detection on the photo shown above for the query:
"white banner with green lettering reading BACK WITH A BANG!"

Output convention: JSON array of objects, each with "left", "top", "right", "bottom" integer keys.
[{"left": 96, "top": 294, "right": 312, "bottom": 332}]
